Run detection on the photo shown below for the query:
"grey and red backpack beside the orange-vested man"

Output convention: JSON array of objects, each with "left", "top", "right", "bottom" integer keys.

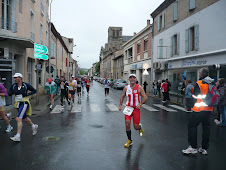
[{"left": 203, "top": 84, "right": 220, "bottom": 107}]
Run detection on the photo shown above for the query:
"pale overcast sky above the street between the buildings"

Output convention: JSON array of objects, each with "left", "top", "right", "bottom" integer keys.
[{"left": 51, "top": 0, "right": 164, "bottom": 68}]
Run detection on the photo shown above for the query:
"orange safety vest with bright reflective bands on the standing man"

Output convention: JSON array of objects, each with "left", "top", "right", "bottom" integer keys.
[{"left": 192, "top": 80, "right": 213, "bottom": 112}]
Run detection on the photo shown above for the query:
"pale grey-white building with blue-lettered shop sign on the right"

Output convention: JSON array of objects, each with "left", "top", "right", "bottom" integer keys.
[{"left": 151, "top": 0, "right": 226, "bottom": 92}]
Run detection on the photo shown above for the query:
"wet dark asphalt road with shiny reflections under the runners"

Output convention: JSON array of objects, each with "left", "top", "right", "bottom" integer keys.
[{"left": 0, "top": 82, "right": 226, "bottom": 170}]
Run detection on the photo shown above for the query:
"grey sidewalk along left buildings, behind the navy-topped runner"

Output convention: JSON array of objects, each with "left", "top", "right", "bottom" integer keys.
[{"left": 5, "top": 94, "right": 60, "bottom": 118}]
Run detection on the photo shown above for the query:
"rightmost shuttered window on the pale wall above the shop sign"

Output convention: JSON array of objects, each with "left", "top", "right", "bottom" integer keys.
[{"left": 185, "top": 25, "right": 199, "bottom": 53}]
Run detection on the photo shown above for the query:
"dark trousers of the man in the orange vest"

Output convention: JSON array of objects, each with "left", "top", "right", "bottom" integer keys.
[{"left": 188, "top": 111, "right": 211, "bottom": 150}]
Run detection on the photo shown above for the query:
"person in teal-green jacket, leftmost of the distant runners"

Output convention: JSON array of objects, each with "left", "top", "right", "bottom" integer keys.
[{"left": 45, "top": 79, "right": 57, "bottom": 109}]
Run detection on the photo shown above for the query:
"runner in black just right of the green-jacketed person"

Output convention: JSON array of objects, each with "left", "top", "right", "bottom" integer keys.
[{"left": 60, "top": 76, "right": 71, "bottom": 106}]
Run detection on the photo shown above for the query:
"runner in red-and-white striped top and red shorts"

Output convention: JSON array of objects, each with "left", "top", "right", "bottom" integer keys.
[{"left": 119, "top": 74, "right": 148, "bottom": 148}]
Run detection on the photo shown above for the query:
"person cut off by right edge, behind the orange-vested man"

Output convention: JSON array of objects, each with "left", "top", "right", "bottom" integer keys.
[{"left": 216, "top": 78, "right": 226, "bottom": 127}]
